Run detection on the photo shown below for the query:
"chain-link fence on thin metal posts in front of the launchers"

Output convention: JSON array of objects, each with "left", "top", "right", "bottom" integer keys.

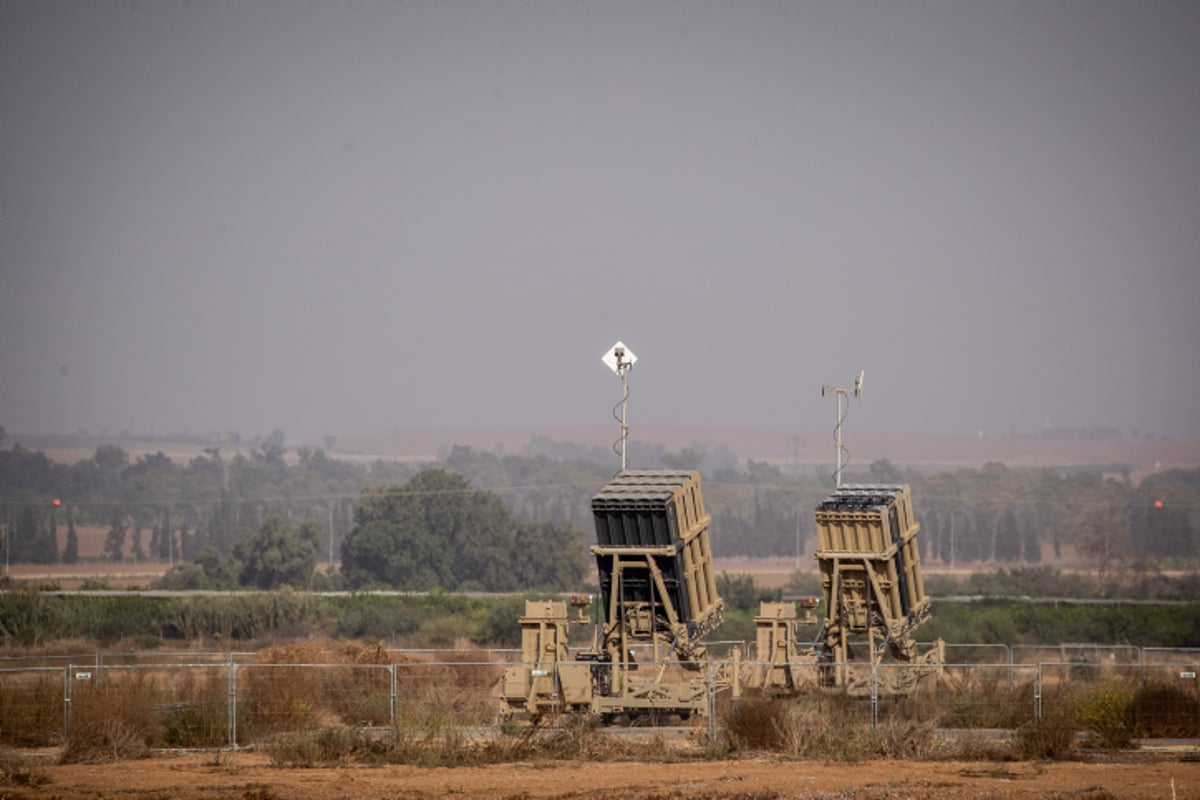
[{"left": 0, "top": 645, "right": 1200, "bottom": 748}]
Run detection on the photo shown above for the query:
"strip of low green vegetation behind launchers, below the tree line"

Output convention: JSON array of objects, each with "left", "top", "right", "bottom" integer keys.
[{"left": 0, "top": 590, "right": 1200, "bottom": 648}]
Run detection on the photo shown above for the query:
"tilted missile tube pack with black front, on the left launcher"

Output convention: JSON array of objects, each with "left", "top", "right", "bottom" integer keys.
[{"left": 592, "top": 470, "right": 724, "bottom": 660}]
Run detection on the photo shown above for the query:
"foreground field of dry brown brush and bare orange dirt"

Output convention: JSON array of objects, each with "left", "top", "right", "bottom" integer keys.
[{"left": 0, "top": 623, "right": 1200, "bottom": 800}]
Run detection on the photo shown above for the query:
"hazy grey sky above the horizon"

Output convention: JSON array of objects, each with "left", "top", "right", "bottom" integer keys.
[{"left": 0, "top": 0, "right": 1200, "bottom": 439}]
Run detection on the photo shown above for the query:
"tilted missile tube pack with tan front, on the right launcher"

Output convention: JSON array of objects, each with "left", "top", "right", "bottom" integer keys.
[{"left": 814, "top": 485, "right": 929, "bottom": 660}]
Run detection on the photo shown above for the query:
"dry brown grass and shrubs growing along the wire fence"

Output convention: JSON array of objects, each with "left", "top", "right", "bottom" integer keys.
[{"left": 18, "top": 640, "right": 1200, "bottom": 766}]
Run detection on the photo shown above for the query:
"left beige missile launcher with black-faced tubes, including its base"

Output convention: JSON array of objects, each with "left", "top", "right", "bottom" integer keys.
[{"left": 502, "top": 470, "right": 725, "bottom": 717}]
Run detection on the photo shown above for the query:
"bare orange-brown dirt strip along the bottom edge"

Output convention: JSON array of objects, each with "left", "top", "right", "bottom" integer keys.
[{"left": 0, "top": 752, "right": 1200, "bottom": 800}]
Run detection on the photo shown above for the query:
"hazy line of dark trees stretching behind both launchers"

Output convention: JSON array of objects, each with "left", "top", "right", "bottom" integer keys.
[{"left": 0, "top": 435, "right": 1200, "bottom": 589}]
